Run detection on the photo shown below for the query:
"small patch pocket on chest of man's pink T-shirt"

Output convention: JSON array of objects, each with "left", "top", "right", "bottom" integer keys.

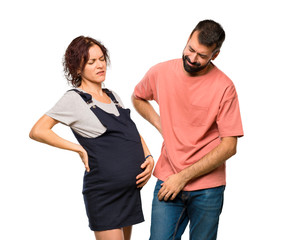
[{"left": 190, "top": 105, "right": 209, "bottom": 127}]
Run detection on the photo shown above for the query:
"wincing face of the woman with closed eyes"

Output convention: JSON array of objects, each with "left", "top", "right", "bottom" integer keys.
[{"left": 81, "top": 44, "right": 107, "bottom": 83}]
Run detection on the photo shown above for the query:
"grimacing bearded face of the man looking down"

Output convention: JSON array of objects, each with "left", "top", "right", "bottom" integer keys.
[{"left": 182, "top": 31, "right": 219, "bottom": 75}]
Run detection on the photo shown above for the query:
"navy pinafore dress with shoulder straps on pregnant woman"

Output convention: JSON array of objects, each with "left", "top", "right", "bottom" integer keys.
[{"left": 72, "top": 89, "right": 144, "bottom": 231}]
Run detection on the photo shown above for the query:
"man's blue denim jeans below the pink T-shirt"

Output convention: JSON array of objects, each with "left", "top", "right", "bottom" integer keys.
[{"left": 150, "top": 180, "right": 225, "bottom": 240}]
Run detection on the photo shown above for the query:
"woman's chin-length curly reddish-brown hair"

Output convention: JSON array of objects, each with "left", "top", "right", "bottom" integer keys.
[{"left": 63, "top": 36, "right": 110, "bottom": 87}]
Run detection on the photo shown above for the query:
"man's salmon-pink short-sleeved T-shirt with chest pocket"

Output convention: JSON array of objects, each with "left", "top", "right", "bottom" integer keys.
[{"left": 134, "top": 59, "right": 243, "bottom": 191}]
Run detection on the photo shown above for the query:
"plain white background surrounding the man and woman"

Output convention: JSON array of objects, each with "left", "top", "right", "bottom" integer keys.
[{"left": 0, "top": 0, "right": 293, "bottom": 240}]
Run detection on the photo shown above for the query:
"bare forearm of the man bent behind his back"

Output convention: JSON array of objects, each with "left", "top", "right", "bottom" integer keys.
[{"left": 131, "top": 95, "right": 162, "bottom": 134}]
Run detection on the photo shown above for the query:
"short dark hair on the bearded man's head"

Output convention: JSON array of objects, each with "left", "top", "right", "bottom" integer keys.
[{"left": 190, "top": 20, "right": 225, "bottom": 51}]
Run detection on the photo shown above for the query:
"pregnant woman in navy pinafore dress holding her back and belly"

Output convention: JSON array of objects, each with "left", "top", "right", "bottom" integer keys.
[{"left": 30, "top": 36, "right": 154, "bottom": 240}]
